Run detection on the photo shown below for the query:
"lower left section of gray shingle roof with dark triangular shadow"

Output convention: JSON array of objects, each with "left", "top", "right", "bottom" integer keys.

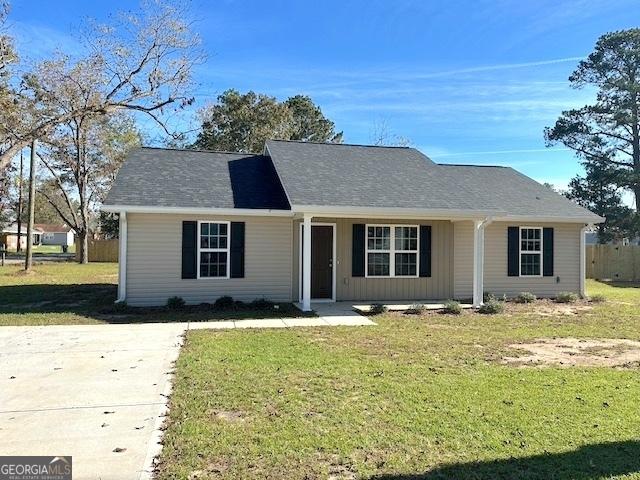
[{"left": 105, "top": 148, "right": 289, "bottom": 210}]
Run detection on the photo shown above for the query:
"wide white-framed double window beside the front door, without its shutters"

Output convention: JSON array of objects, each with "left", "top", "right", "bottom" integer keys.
[{"left": 366, "top": 225, "right": 418, "bottom": 277}]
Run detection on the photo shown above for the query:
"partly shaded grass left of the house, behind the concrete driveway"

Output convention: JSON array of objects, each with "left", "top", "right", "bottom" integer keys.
[{"left": 0, "top": 262, "right": 312, "bottom": 326}]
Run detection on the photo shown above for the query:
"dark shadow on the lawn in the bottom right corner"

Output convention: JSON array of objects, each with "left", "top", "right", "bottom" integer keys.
[{"left": 371, "top": 440, "right": 640, "bottom": 480}]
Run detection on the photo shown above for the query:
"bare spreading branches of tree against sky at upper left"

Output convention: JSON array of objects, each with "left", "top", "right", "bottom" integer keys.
[{"left": 0, "top": 1, "right": 203, "bottom": 170}]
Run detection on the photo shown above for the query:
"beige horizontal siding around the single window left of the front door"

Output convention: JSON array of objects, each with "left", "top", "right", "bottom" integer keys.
[{"left": 126, "top": 213, "right": 293, "bottom": 306}]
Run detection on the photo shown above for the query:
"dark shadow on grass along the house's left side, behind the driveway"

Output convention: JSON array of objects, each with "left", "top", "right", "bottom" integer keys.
[{"left": 0, "top": 283, "right": 314, "bottom": 323}]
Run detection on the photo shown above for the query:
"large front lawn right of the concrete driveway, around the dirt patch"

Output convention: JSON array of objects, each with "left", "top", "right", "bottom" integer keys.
[{"left": 157, "top": 281, "right": 640, "bottom": 480}]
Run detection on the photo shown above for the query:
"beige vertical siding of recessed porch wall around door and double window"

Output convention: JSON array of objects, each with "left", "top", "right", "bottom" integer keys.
[{"left": 292, "top": 218, "right": 453, "bottom": 301}]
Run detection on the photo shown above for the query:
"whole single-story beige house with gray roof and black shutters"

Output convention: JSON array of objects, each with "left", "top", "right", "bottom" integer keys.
[{"left": 103, "top": 141, "right": 603, "bottom": 310}]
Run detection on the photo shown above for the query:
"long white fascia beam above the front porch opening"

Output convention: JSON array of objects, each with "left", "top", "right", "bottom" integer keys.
[{"left": 292, "top": 205, "right": 505, "bottom": 220}]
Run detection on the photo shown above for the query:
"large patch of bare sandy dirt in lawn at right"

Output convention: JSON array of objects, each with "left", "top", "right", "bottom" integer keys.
[{"left": 502, "top": 338, "right": 640, "bottom": 367}]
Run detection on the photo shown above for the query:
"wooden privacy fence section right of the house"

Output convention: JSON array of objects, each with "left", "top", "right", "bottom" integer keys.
[{"left": 585, "top": 245, "right": 640, "bottom": 282}]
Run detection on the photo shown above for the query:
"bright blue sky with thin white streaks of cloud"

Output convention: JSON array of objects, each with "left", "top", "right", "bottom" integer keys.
[{"left": 10, "top": 0, "right": 640, "bottom": 187}]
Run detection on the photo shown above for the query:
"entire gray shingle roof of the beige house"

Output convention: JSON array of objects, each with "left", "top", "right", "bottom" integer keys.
[{"left": 105, "top": 140, "right": 599, "bottom": 222}]
